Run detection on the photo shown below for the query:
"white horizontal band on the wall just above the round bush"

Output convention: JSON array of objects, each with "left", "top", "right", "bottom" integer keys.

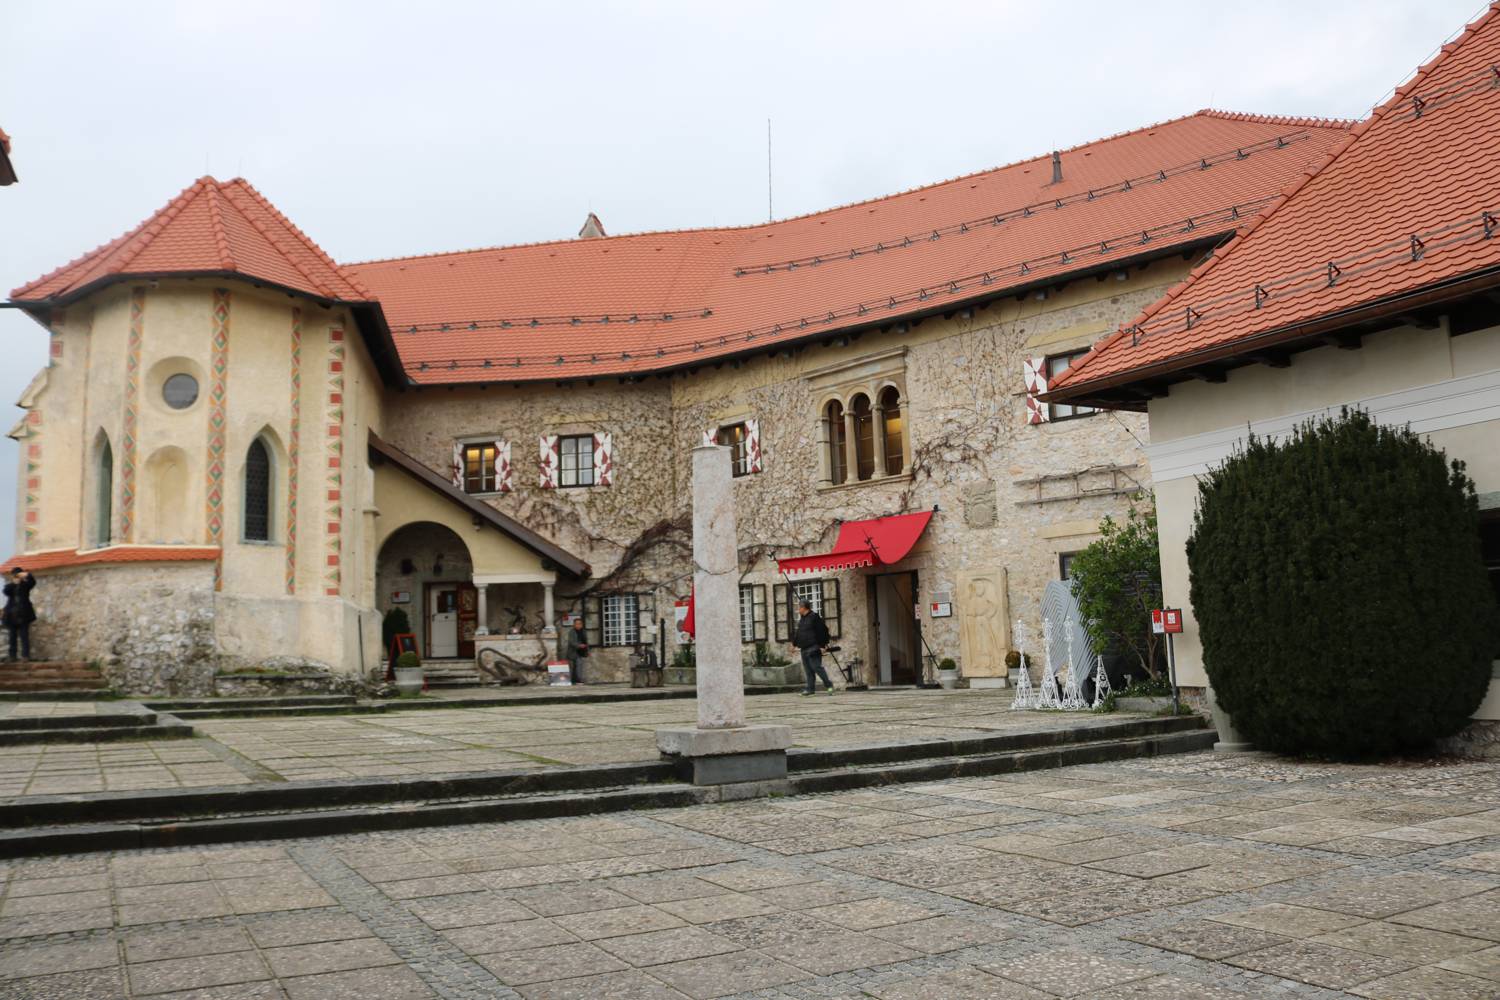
[{"left": 1146, "top": 369, "right": 1500, "bottom": 483}]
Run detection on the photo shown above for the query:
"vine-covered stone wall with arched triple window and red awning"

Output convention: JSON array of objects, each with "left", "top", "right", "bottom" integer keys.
[{"left": 372, "top": 256, "right": 1188, "bottom": 682}]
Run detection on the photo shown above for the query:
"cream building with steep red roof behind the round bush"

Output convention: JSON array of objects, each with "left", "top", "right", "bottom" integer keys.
[{"left": 1049, "top": 7, "right": 1500, "bottom": 743}]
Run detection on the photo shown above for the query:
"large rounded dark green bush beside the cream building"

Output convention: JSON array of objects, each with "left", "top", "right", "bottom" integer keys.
[{"left": 1188, "top": 411, "right": 1497, "bottom": 757}]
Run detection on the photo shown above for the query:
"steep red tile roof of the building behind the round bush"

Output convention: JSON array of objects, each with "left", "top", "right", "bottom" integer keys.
[{"left": 1049, "top": 3, "right": 1500, "bottom": 399}]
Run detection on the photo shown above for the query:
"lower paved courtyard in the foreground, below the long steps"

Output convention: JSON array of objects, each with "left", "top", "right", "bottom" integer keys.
[{"left": 0, "top": 755, "right": 1500, "bottom": 1000}]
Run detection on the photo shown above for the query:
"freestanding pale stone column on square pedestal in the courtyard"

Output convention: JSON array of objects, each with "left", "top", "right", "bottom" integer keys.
[{"left": 657, "top": 445, "right": 792, "bottom": 798}]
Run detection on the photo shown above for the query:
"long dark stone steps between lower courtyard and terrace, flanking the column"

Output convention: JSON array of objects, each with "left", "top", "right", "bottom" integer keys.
[{"left": 0, "top": 727, "right": 1218, "bottom": 858}]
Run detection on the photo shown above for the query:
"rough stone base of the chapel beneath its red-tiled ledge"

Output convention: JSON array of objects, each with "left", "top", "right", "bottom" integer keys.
[{"left": 32, "top": 562, "right": 219, "bottom": 697}]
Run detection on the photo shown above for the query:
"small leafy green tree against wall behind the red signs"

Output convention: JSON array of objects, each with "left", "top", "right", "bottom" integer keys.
[{"left": 1073, "top": 501, "right": 1161, "bottom": 678}]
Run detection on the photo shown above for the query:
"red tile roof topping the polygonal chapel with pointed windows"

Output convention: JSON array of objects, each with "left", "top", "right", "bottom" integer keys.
[{"left": 11, "top": 177, "right": 371, "bottom": 303}]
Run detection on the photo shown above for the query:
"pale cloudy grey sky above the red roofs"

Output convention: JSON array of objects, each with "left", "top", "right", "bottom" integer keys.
[{"left": 0, "top": 0, "right": 1481, "bottom": 558}]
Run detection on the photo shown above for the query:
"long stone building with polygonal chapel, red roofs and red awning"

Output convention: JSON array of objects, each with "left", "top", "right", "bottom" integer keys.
[{"left": 2, "top": 111, "right": 1349, "bottom": 691}]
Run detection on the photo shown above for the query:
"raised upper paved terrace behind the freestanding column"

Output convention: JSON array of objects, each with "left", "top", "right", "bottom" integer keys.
[{"left": 0, "top": 691, "right": 1152, "bottom": 799}]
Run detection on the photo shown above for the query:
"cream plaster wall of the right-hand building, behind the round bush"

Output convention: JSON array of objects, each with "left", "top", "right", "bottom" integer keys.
[{"left": 1151, "top": 324, "right": 1500, "bottom": 718}]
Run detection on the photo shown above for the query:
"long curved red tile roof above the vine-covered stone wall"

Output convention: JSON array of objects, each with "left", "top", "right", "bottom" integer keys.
[{"left": 345, "top": 111, "right": 1349, "bottom": 384}]
